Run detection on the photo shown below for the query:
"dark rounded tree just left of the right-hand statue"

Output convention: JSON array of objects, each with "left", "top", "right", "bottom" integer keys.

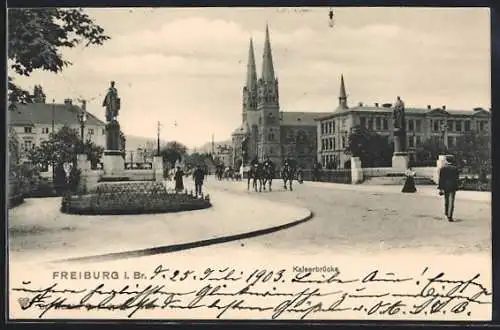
[{"left": 345, "top": 126, "right": 394, "bottom": 167}]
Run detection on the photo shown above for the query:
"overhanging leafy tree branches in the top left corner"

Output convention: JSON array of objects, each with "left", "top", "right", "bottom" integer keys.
[{"left": 7, "top": 8, "right": 109, "bottom": 108}]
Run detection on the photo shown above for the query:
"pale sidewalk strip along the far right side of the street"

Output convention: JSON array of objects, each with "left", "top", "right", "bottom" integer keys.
[{"left": 298, "top": 181, "right": 491, "bottom": 203}]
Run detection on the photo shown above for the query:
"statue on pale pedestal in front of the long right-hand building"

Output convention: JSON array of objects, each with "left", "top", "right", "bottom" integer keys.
[{"left": 392, "top": 96, "right": 408, "bottom": 171}]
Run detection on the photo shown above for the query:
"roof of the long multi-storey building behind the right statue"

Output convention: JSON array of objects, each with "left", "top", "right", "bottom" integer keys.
[{"left": 316, "top": 106, "right": 490, "bottom": 120}]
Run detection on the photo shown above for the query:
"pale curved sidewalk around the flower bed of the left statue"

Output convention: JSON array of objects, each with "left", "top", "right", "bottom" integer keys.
[{"left": 9, "top": 190, "right": 311, "bottom": 262}]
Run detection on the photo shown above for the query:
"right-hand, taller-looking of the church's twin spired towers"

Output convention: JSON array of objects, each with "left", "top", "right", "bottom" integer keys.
[{"left": 257, "top": 24, "right": 281, "bottom": 163}]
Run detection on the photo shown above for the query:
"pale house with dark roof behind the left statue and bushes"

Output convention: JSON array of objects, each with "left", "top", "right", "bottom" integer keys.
[{"left": 8, "top": 98, "right": 106, "bottom": 161}]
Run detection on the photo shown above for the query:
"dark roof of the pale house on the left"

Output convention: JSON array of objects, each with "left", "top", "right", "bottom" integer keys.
[{"left": 7, "top": 103, "right": 106, "bottom": 126}]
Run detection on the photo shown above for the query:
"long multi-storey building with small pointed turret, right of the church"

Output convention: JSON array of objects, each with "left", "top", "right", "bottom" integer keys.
[{"left": 317, "top": 76, "right": 491, "bottom": 168}]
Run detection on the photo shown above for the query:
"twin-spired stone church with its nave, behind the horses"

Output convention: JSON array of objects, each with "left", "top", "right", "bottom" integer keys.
[{"left": 231, "top": 26, "right": 327, "bottom": 168}]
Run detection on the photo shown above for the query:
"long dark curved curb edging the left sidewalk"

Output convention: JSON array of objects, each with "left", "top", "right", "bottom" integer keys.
[{"left": 52, "top": 209, "right": 314, "bottom": 263}]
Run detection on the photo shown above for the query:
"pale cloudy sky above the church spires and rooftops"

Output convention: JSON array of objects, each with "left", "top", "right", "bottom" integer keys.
[{"left": 9, "top": 7, "right": 491, "bottom": 147}]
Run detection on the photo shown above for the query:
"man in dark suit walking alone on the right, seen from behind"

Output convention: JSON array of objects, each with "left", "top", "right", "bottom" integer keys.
[{"left": 438, "top": 156, "right": 459, "bottom": 222}]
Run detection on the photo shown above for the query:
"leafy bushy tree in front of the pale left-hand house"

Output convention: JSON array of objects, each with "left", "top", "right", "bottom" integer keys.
[{"left": 27, "top": 126, "right": 104, "bottom": 167}]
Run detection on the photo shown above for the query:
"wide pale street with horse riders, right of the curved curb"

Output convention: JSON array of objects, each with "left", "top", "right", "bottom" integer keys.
[{"left": 201, "top": 177, "right": 491, "bottom": 254}]
